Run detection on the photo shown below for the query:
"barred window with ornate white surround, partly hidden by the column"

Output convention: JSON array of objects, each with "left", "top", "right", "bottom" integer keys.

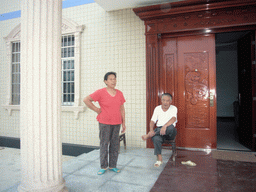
[{"left": 3, "top": 18, "right": 84, "bottom": 119}]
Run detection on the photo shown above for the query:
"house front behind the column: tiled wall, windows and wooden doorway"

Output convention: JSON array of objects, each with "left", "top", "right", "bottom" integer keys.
[{"left": 0, "top": 0, "right": 255, "bottom": 152}]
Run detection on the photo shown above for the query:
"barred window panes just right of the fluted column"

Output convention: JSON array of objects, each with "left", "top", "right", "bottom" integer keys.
[{"left": 61, "top": 35, "right": 75, "bottom": 105}]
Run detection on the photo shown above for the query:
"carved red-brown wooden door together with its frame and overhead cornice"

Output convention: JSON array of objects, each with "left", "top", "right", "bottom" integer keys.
[{"left": 133, "top": 0, "right": 256, "bottom": 149}]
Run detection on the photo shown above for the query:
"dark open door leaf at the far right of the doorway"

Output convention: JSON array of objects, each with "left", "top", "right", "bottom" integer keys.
[{"left": 238, "top": 31, "right": 256, "bottom": 151}]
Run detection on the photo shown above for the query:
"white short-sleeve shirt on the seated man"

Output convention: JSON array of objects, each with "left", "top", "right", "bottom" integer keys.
[{"left": 151, "top": 105, "right": 178, "bottom": 127}]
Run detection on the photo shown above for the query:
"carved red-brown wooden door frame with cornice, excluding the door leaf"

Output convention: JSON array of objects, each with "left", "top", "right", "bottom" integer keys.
[{"left": 133, "top": 0, "right": 256, "bottom": 148}]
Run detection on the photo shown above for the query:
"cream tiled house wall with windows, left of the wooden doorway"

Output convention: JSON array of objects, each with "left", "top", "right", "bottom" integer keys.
[{"left": 0, "top": 0, "right": 146, "bottom": 147}]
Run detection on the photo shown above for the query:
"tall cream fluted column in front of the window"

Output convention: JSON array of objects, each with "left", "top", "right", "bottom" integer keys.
[{"left": 19, "top": 0, "right": 67, "bottom": 192}]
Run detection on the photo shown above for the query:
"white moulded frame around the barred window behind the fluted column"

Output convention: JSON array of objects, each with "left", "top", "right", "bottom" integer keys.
[{"left": 3, "top": 18, "right": 85, "bottom": 119}]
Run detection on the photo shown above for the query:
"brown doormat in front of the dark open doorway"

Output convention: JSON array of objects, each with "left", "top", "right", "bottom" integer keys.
[{"left": 212, "top": 150, "right": 256, "bottom": 162}]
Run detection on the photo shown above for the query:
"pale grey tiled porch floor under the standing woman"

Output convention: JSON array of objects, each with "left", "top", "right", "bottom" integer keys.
[{"left": 0, "top": 147, "right": 171, "bottom": 192}]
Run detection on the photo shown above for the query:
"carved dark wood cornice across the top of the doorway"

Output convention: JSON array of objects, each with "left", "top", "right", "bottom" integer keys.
[{"left": 133, "top": 0, "right": 256, "bottom": 35}]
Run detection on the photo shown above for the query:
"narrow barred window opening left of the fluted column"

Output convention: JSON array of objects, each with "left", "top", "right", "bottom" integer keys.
[{"left": 12, "top": 42, "right": 20, "bottom": 105}]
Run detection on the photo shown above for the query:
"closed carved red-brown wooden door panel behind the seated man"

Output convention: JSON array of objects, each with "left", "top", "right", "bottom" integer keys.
[{"left": 158, "top": 34, "right": 217, "bottom": 149}]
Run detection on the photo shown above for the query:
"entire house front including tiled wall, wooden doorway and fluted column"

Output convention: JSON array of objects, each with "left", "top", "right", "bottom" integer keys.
[{"left": 0, "top": 0, "right": 256, "bottom": 191}]
